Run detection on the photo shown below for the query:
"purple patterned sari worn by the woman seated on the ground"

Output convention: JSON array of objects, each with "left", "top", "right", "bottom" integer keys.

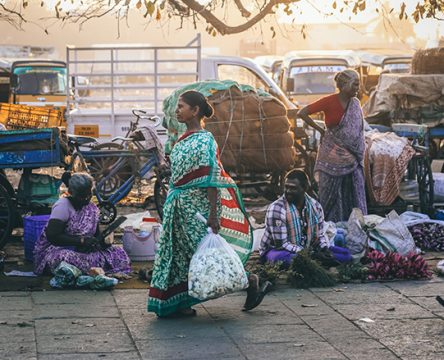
[{"left": 34, "top": 203, "right": 131, "bottom": 274}]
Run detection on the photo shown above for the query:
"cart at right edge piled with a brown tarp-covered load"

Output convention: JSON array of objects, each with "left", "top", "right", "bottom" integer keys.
[{"left": 364, "top": 67, "right": 444, "bottom": 215}]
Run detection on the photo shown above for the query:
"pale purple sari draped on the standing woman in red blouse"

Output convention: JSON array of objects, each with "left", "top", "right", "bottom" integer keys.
[{"left": 315, "top": 98, "right": 367, "bottom": 222}]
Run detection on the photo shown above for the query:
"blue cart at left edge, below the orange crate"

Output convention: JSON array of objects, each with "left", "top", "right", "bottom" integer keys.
[{"left": 0, "top": 128, "right": 68, "bottom": 248}]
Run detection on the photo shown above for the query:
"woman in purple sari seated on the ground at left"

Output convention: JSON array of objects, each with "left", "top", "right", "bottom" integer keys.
[{"left": 34, "top": 173, "right": 131, "bottom": 274}]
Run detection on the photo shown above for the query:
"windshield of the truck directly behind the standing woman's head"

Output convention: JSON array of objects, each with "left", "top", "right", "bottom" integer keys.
[{"left": 288, "top": 66, "right": 346, "bottom": 94}]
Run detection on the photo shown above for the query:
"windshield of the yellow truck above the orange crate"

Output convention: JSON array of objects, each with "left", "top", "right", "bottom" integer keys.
[{"left": 14, "top": 66, "right": 66, "bottom": 95}]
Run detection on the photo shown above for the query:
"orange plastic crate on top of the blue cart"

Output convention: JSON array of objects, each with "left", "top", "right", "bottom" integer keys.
[{"left": 0, "top": 103, "right": 65, "bottom": 130}]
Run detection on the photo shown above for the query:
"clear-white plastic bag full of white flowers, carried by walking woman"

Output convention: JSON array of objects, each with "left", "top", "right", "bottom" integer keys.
[{"left": 188, "top": 228, "right": 248, "bottom": 300}]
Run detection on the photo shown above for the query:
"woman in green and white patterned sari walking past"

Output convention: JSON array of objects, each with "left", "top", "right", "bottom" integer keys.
[{"left": 148, "top": 91, "right": 270, "bottom": 317}]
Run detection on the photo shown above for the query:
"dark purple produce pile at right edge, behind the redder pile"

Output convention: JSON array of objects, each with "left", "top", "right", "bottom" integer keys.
[{"left": 409, "top": 223, "right": 444, "bottom": 251}]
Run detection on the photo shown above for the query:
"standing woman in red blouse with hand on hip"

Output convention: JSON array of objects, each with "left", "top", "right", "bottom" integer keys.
[{"left": 298, "top": 70, "right": 367, "bottom": 222}]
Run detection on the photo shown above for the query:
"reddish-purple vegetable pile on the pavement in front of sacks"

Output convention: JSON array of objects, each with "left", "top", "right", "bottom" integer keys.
[{"left": 366, "top": 250, "right": 432, "bottom": 280}]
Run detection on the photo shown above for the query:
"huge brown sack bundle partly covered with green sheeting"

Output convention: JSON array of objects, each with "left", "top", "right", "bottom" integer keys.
[{"left": 164, "top": 81, "right": 296, "bottom": 174}]
